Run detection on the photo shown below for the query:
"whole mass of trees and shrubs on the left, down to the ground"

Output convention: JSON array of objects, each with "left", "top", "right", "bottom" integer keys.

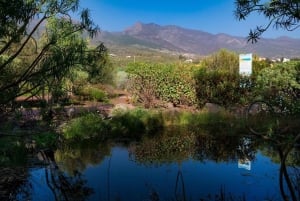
[{"left": 0, "top": 0, "right": 113, "bottom": 111}]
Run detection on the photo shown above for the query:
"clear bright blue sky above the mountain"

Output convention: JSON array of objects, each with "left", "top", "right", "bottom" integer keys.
[{"left": 80, "top": 0, "right": 300, "bottom": 38}]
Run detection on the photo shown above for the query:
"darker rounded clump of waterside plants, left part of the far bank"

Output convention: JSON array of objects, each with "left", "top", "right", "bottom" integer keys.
[{"left": 62, "top": 109, "right": 164, "bottom": 140}]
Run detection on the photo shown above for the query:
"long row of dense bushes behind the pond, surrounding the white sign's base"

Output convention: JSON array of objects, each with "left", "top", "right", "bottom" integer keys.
[{"left": 126, "top": 49, "right": 299, "bottom": 113}]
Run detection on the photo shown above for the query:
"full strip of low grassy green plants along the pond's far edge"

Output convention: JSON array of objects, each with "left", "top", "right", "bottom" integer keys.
[{"left": 62, "top": 109, "right": 247, "bottom": 140}]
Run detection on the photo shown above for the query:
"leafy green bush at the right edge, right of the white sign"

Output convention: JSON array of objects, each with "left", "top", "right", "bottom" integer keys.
[{"left": 255, "top": 62, "right": 300, "bottom": 114}]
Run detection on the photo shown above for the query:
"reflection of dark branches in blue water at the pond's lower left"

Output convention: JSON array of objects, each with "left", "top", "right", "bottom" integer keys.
[{"left": 11, "top": 150, "right": 93, "bottom": 201}]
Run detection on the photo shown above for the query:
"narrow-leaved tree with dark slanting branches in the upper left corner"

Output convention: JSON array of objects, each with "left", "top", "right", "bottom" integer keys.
[{"left": 0, "top": 0, "right": 103, "bottom": 110}]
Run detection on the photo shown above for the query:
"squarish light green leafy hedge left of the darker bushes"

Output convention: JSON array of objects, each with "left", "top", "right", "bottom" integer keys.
[{"left": 127, "top": 63, "right": 196, "bottom": 107}]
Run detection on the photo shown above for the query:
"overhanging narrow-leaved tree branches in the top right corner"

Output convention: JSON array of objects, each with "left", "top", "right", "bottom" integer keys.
[{"left": 235, "top": 0, "right": 300, "bottom": 43}]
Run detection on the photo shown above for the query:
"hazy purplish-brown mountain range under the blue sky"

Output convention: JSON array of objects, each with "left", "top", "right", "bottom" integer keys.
[{"left": 96, "top": 22, "right": 300, "bottom": 58}]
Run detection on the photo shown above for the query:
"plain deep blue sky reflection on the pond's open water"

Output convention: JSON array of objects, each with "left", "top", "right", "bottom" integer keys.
[{"left": 22, "top": 147, "right": 281, "bottom": 201}]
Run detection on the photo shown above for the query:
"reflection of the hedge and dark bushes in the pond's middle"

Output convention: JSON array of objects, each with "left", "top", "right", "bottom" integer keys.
[{"left": 130, "top": 126, "right": 259, "bottom": 165}]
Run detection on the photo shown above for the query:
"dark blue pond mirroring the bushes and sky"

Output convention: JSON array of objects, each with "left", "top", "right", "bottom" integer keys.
[{"left": 12, "top": 133, "right": 300, "bottom": 201}]
